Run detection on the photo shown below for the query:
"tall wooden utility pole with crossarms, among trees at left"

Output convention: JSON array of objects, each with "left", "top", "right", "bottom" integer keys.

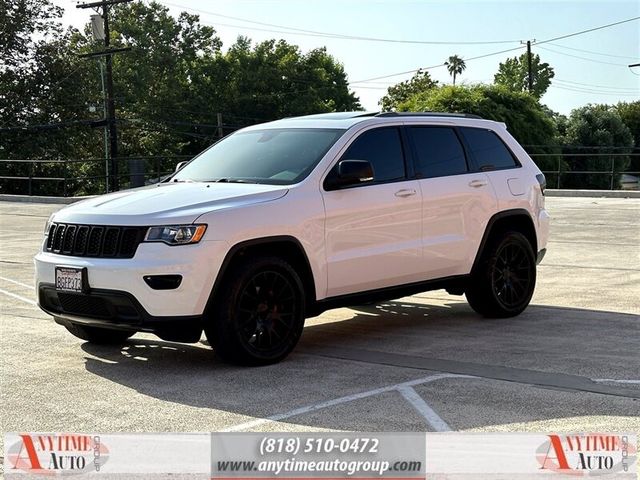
[{"left": 76, "top": 0, "right": 132, "bottom": 191}]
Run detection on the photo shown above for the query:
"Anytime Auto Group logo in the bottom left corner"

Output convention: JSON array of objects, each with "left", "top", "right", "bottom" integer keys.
[{"left": 5, "top": 433, "right": 109, "bottom": 475}]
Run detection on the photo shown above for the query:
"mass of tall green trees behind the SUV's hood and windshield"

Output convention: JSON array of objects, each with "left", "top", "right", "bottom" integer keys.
[{"left": 0, "top": 0, "right": 360, "bottom": 194}]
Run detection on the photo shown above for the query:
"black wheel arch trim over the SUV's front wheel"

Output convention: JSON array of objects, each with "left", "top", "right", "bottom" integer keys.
[{"left": 206, "top": 235, "right": 316, "bottom": 310}]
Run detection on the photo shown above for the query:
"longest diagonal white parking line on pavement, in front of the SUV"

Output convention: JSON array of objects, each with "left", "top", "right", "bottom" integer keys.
[{"left": 221, "top": 373, "right": 472, "bottom": 432}]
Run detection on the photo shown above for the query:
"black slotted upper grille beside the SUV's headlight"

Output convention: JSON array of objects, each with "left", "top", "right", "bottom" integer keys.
[{"left": 46, "top": 223, "right": 147, "bottom": 258}]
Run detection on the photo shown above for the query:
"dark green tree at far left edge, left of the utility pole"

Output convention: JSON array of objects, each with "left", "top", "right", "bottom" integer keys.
[{"left": 0, "top": 0, "right": 98, "bottom": 194}]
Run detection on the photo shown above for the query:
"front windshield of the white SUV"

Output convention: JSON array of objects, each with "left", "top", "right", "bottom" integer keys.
[{"left": 171, "top": 128, "right": 344, "bottom": 185}]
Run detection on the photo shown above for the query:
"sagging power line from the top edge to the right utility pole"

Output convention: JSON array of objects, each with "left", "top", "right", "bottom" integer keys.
[{"left": 160, "top": 0, "right": 519, "bottom": 45}]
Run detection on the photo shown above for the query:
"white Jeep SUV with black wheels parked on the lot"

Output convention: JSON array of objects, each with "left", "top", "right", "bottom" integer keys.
[{"left": 35, "top": 112, "right": 549, "bottom": 364}]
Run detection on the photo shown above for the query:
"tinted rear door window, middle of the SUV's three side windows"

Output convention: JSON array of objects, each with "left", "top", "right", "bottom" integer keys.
[{"left": 411, "top": 127, "right": 468, "bottom": 177}]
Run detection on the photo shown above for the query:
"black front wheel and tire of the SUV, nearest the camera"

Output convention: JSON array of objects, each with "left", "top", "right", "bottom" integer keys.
[{"left": 204, "top": 257, "right": 305, "bottom": 365}]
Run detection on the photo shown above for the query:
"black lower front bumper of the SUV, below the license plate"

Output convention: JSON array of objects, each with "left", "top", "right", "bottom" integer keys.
[{"left": 38, "top": 283, "right": 203, "bottom": 342}]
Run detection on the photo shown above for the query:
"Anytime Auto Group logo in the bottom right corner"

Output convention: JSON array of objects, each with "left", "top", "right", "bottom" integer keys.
[{"left": 536, "top": 434, "right": 636, "bottom": 476}]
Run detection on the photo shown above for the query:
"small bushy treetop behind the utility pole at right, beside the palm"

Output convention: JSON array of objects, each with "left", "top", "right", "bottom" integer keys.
[{"left": 493, "top": 53, "right": 555, "bottom": 98}]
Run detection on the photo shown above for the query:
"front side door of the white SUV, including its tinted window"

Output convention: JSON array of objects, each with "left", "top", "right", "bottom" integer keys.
[{"left": 322, "top": 126, "right": 422, "bottom": 297}]
